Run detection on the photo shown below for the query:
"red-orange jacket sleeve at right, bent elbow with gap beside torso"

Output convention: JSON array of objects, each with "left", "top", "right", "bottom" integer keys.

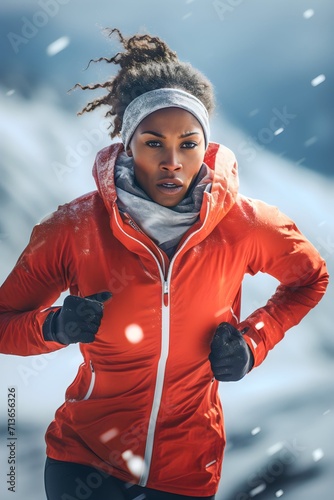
[{"left": 238, "top": 202, "right": 329, "bottom": 366}]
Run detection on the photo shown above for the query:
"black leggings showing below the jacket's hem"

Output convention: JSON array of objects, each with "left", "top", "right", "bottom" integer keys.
[{"left": 44, "top": 458, "right": 215, "bottom": 500}]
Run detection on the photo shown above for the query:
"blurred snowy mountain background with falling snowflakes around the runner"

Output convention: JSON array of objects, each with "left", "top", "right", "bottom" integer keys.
[{"left": 0, "top": 0, "right": 334, "bottom": 500}]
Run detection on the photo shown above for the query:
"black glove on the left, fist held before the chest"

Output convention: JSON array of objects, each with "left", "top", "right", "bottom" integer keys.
[{"left": 43, "top": 292, "right": 111, "bottom": 345}]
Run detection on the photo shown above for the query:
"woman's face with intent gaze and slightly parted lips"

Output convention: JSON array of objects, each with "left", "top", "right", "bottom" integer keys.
[{"left": 127, "top": 108, "right": 205, "bottom": 207}]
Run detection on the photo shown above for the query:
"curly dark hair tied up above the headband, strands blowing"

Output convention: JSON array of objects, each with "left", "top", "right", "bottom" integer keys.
[{"left": 73, "top": 28, "right": 214, "bottom": 138}]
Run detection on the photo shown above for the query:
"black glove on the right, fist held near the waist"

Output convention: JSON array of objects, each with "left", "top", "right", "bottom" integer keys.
[{"left": 209, "top": 323, "right": 254, "bottom": 382}]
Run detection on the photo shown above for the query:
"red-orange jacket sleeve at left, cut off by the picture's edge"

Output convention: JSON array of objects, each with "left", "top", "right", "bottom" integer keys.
[{"left": 0, "top": 212, "right": 70, "bottom": 356}]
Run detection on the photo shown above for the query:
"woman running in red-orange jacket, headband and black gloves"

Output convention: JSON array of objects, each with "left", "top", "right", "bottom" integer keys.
[{"left": 0, "top": 30, "right": 328, "bottom": 500}]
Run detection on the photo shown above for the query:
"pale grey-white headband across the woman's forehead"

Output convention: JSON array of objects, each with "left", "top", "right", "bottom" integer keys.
[{"left": 121, "top": 88, "right": 210, "bottom": 150}]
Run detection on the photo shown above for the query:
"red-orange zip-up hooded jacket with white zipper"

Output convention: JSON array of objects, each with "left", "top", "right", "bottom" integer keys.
[{"left": 0, "top": 143, "right": 328, "bottom": 496}]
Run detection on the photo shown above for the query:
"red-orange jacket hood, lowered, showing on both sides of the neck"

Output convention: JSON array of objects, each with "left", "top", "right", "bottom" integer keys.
[{"left": 93, "top": 143, "right": 239, "bottom": 230}]
